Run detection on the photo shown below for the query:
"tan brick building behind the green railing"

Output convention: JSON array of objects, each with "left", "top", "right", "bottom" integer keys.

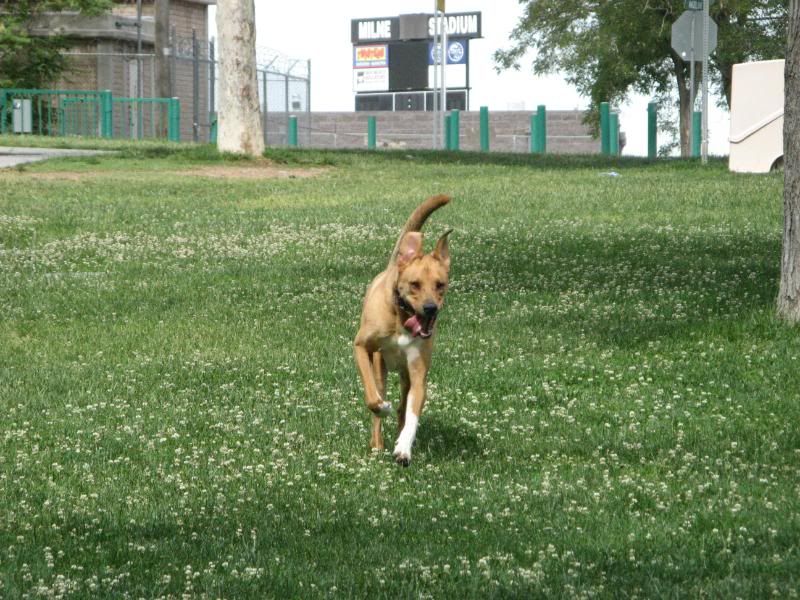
[{"left": 21, "top": 0, "right": 216, "bottom": 141}]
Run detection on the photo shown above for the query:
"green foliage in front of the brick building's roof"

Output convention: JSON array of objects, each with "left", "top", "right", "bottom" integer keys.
[{"left": 0, "top": 0, "right": 112, "bottom": 88}]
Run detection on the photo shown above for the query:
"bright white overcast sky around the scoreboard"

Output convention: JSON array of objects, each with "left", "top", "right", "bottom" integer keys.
[{"left": 210, "top": 0, "right": 729, "bottom": 156}]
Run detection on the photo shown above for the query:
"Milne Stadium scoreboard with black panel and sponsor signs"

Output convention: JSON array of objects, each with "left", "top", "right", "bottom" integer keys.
[{"left": 350, "top": 12, "right": 481, "bottom": 111}]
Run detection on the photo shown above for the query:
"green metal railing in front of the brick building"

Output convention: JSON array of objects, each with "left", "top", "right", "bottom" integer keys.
[{"left": 0, "top": 88, "right": 180, "bottom": 142}]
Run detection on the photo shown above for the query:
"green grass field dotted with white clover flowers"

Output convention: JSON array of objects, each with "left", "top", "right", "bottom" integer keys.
[{"left": 0, "top": 139, "right": 800, "bottom": 598}]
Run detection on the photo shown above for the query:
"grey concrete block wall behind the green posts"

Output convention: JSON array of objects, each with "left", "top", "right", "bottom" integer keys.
[{"left": 267, "top": 111, "right": 600, "bottom": 154}]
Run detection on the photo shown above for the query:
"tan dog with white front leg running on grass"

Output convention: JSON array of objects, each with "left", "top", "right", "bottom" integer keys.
[{"left": 354, "top": 195, "right": 450, "bottom": 466}]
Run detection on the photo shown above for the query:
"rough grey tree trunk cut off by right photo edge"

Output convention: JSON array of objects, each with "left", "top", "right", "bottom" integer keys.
[{"left": 778, "top": 0, "right": 800, "bottom": 323}]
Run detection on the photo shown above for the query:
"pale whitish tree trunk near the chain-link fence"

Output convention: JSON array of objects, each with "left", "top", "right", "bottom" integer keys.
[{"left": 217, "top": 0, "right": 264, "bottom": 156}]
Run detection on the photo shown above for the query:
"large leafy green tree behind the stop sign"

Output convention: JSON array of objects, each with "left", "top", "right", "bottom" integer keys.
[{"left": 495, "top": 0, "right": 788, "bottom": 156}]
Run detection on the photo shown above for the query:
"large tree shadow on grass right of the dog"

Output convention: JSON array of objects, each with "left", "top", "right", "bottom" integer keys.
[{"left": 458, "top": 225, "right": 780, "bottom": 346}]
